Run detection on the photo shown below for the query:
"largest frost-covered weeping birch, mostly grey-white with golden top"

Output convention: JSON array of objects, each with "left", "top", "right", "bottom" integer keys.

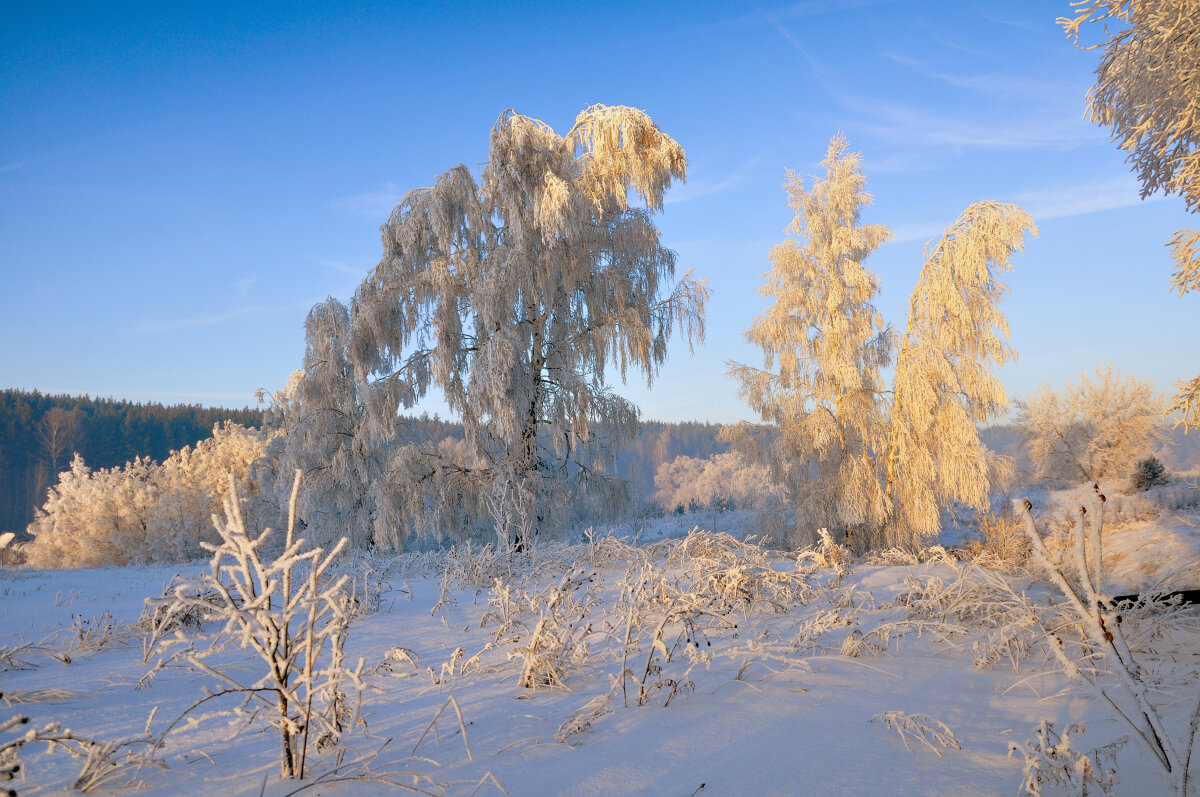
[{"left": 349, "top": 106, "right": 707, "bottom": 544}]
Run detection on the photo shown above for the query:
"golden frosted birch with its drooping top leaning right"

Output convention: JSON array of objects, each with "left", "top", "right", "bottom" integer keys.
[{"left": 887, "top": 202, "right": 1037, "bottom": 544}]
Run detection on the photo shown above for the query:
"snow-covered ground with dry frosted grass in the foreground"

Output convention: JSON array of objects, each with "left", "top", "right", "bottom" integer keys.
[{"left": 0, "top": 499, "right": 1200, "bottom": 797}]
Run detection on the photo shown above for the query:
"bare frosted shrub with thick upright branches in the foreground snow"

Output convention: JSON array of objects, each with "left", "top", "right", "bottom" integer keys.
[{"left": 152, "top": 472, "right": 362, "bottom": 778}]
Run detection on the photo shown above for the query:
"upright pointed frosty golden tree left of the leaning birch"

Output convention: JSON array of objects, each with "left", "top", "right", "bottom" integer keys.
[{"left": 722, "top": 133, "right": 892, "bottom": 542}]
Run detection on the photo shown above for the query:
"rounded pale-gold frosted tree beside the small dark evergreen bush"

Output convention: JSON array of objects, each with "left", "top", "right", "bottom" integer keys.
[{"left": 1016, "top": 365, "right": 1165, "bottom": 481}]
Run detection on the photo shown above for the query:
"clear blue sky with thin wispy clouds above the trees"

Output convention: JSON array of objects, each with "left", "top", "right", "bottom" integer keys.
[{"left": 0, "top": 0, "right": 1200, "bottom": 423}]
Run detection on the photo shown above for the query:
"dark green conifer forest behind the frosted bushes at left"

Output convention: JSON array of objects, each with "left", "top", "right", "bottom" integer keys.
[{"left": 0, "top": 390, "right": 262, "bottom": 531}]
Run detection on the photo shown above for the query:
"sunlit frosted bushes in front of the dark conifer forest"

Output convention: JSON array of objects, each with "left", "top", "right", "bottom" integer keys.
[{"left": 24, "top": 424, "right": 265, "bottom": 568}]
